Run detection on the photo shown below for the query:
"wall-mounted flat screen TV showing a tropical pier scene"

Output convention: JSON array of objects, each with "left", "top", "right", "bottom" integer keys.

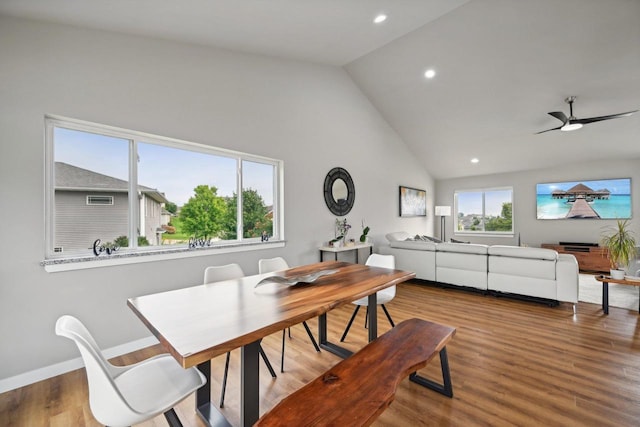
[{"left": 536, "top": 178, "right": 631, "bottom": 219}]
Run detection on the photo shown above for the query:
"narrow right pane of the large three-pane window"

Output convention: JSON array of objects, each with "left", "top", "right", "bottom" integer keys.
[{"left": 242, "top": 160, "right": 275, "bottom": 238}]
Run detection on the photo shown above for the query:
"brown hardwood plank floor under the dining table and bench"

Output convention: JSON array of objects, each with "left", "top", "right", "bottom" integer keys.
[{"left": 0, "top": 282, "right": 640, "bottom": 427}]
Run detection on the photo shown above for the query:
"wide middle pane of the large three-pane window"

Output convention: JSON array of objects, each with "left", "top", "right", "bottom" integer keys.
[{"left": 138, "top": 143, "right": 237, "bottom": 245}]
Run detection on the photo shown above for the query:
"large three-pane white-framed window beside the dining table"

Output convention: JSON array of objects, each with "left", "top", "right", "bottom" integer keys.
[{"left": 45, "top": 116, "right": 284, "bottom": 259}]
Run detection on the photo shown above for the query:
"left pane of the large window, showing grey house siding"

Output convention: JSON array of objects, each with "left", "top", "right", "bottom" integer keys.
[{"left": 53, "top": 127, "right": 129, "bottom": 253}]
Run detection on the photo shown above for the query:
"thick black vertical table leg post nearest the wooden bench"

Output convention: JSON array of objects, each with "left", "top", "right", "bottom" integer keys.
[{"left": 240, "top": 340, "right": 260, "bottom": 426}]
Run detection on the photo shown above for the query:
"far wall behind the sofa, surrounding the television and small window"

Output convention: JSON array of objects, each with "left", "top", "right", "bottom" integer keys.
[{"left": 436, "top": 160, "right": 640, "bottom": 246}]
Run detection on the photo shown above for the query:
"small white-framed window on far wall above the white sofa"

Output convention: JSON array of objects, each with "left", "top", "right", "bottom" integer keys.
[{"left": 454, "top": 187, "right": 513, "bottom": 235}]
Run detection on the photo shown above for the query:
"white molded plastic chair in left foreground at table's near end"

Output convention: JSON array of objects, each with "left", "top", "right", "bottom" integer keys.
[{"left": 56, "top": 315, "right": 207, "bottom": 426}]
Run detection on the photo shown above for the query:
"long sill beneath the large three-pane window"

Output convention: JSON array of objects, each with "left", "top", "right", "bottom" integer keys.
[{"left": 40, "top": 240, "right": 285, "bottom": 273}]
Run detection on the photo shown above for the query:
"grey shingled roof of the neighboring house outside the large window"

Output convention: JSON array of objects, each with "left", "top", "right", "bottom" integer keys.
[{"left": 54, "top": 162, "right": 169, "bottom": 203}]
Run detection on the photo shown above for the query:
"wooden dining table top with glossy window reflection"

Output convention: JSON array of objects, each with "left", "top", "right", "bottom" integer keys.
[{"left": 127, "top": 261, "right": 415, "bottom": 368}]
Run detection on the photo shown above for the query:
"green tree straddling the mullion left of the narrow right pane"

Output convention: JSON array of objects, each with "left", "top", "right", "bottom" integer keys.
[{"left": 225, "top": 188, "right": 273, "bottom": 239}]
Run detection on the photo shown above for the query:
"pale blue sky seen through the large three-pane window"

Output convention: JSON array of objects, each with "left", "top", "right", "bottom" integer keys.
[{"left": 54, "top": 128, "right": 274, "bottom": 206}]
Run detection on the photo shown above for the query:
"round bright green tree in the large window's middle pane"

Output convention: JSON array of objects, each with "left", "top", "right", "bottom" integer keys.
[{"left": 180, "top": 185, "right": 227, "bottom": 239}]
